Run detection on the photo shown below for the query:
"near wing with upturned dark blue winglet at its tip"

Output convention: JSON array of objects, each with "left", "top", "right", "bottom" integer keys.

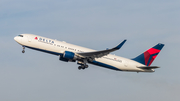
[{"left": 77, "top": 40, "right": 126, "bottom": 59}]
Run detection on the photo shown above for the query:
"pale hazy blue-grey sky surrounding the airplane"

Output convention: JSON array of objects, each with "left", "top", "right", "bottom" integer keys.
[{"left": 0, "top": 0, "right": 180, "bottom": 101}]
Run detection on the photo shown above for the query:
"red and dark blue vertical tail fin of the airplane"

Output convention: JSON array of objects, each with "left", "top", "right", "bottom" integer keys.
[{"left": 132, "top": 43, "right": 164, "bottom": 66}]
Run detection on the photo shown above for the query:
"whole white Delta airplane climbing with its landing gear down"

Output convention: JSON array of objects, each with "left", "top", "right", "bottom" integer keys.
[{"left": 14, "top": 34, "right": 164, "bottom": 73}]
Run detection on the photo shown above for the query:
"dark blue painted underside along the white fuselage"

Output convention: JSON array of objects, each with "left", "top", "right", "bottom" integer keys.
[{"left": 25, "top": 46, "right": 121, "bottom": 71}]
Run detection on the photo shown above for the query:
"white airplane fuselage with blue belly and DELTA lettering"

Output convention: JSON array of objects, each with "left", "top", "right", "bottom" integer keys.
[{"left": 14, "top": 34, "right": 154, "bottom": 72}]
